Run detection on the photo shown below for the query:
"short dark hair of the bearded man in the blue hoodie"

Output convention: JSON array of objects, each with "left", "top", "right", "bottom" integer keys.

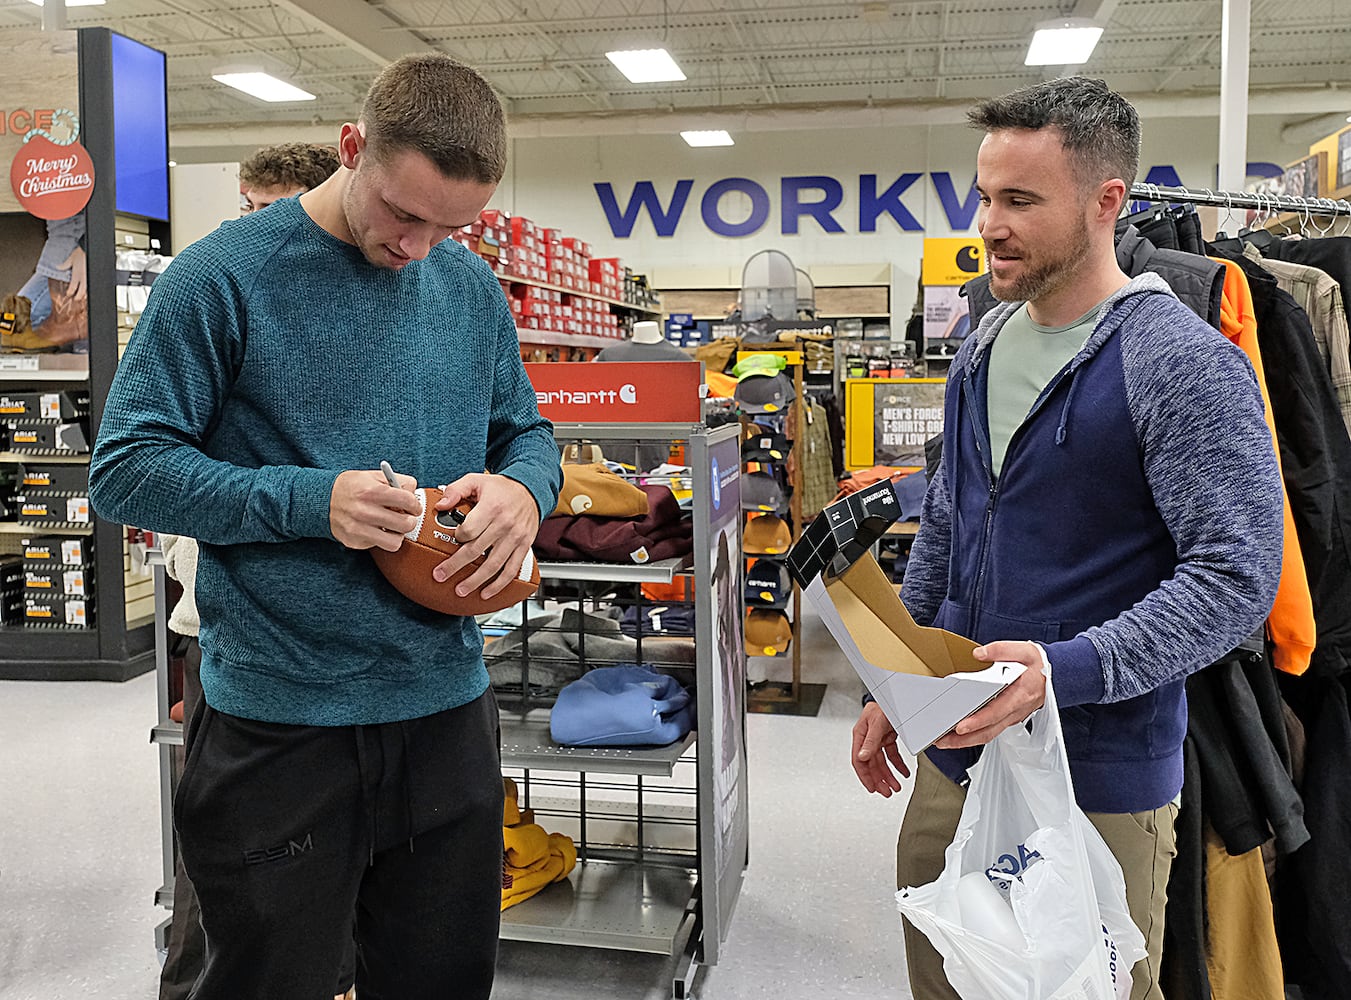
[{"left": 966, "top": 77, "right": 1140, "bottom": 188}]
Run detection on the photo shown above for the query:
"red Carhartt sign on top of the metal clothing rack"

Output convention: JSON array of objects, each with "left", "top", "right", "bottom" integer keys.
[{"left": 526, "top": 359, "right": 705, "bottom": 423}]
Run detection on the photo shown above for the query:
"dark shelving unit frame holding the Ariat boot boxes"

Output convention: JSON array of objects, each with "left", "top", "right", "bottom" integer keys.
[{"left": 0, "top": 28, "right": 168, "bottom": 680}]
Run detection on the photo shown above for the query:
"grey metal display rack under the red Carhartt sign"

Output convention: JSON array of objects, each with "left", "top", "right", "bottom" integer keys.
[{"left": 150, "top": 424, "right": 748, "bottom": 1000}]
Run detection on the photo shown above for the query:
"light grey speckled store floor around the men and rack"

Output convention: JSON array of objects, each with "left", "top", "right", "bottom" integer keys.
[{"left": 0, "top": 608, "right": 909, "bottom": 1000}]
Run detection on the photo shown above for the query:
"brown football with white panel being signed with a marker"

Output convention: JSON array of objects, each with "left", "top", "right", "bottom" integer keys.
[{"left": 370, "top": 486, "right": 539, "bottom": 615}]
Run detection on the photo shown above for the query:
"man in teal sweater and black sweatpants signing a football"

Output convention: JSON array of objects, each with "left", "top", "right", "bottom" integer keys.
[{"left": 91, "top": 55, "right": 561, "bottom": 1000}]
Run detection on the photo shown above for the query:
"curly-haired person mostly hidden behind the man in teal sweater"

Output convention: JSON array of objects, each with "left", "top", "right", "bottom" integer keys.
[{"left": 151, "top": 142, "right": 343, "bottom": 1000}]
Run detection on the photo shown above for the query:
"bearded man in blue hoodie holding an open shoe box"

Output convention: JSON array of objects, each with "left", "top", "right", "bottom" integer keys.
[{"left": 852, "top": 77, "right": 1281, "bottom": 1000}]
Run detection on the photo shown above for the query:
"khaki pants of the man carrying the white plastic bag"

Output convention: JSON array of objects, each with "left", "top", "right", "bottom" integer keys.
[{"left": 896, "top": 754, "right": 1177, "bottom": 1000}]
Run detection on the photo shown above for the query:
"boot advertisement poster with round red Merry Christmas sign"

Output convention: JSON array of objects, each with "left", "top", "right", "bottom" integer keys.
[{"left": 0, "top": 31, "right": 93, "bottom": 354}]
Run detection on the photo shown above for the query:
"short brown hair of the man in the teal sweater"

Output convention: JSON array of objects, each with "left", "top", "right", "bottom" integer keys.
[{"left": 361, "top": 53, "right": 507, "bottom": 184}]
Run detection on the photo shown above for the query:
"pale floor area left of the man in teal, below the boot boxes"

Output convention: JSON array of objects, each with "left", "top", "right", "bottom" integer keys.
[{"left": 0, "top": 664, "right": 166, "bottom": 1000}]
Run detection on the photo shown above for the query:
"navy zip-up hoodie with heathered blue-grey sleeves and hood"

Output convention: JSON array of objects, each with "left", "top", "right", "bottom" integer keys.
[{"left": 901, "top": 273, "right": 1282, "bottom": 812}]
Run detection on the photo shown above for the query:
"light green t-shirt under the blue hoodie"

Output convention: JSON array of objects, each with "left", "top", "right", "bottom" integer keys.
[{"left": 986, "top": 300, "right": 1105, "bottom": 477}]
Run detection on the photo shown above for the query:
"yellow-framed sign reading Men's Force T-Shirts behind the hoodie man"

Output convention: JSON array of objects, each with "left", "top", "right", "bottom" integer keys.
[{"left": 844, "top": 378, "right": 946, "bottom": 469}]
